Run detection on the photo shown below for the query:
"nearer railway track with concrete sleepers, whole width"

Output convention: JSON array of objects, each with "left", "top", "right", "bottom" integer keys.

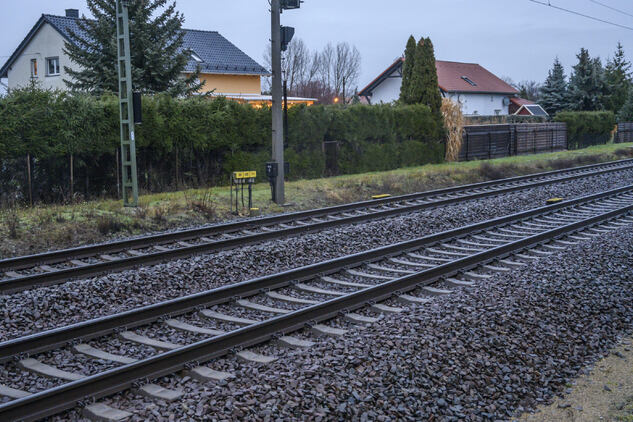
[{"left": 0, "top": 185, "right": 633, "bottom": 421}]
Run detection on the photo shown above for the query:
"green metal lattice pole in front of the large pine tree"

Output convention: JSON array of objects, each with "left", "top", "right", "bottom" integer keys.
[{"left": 116, "top": 0, "right": 138, "bottom": 207}]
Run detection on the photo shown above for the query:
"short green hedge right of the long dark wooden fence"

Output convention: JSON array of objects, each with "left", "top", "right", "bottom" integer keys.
[{"left": 554, "top": 111, "right": 616, "bottom": 149}]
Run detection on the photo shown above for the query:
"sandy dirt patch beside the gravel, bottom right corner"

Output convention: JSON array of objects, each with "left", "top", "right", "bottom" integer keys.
[{"left": 519, "top": 337, "right": 633, "bottom": 422}]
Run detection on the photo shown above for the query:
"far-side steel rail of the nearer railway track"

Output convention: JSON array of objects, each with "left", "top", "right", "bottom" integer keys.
[{"left": 0, "top": 185, "right": 633, "bottom": 362}]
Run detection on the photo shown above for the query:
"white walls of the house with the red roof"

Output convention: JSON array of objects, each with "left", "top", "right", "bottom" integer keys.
[{"left": 371, "top": 73, "right": 510, "bottom": 116}]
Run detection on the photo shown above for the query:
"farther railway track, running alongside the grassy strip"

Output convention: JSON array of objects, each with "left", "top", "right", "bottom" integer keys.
[{"left": 0, "top": 159, "right": 633, "bottom": 294}]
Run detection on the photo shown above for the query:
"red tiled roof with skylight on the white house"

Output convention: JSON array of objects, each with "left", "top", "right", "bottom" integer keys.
[{"left": 435, "top": 60, "right": 519, "bottom": 94}]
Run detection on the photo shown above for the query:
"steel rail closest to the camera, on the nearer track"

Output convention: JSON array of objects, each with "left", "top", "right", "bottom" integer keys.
[{"left": 0, "top": 192, "right": 633, "bottom": 421}]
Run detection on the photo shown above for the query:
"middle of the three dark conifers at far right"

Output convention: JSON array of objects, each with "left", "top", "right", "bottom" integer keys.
[{"left": 566, "top": 48, "right": 607, "bottom": 111}]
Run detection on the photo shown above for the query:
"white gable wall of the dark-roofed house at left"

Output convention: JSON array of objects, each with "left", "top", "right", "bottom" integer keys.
[{"left": 8, "top": 23, "right": 71, "bottom": 89}]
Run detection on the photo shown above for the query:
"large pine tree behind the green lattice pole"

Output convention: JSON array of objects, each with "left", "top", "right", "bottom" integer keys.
[{"left": 64, "top": 0, "right": 201, "bottom": 96}]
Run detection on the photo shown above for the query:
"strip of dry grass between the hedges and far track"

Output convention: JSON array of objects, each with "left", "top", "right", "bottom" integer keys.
[{"left": 0, "top": 144, "right": 633, "bottom": 259}]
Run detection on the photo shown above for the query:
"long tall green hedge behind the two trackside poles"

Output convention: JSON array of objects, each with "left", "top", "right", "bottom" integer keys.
[{"left": 0, "top": 88, "right": 444, "bottom": 201}]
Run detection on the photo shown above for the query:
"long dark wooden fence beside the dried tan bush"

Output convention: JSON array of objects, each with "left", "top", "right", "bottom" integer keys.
[{"left": 459, "top": 123, "right": 567, "bottom": 161}]
